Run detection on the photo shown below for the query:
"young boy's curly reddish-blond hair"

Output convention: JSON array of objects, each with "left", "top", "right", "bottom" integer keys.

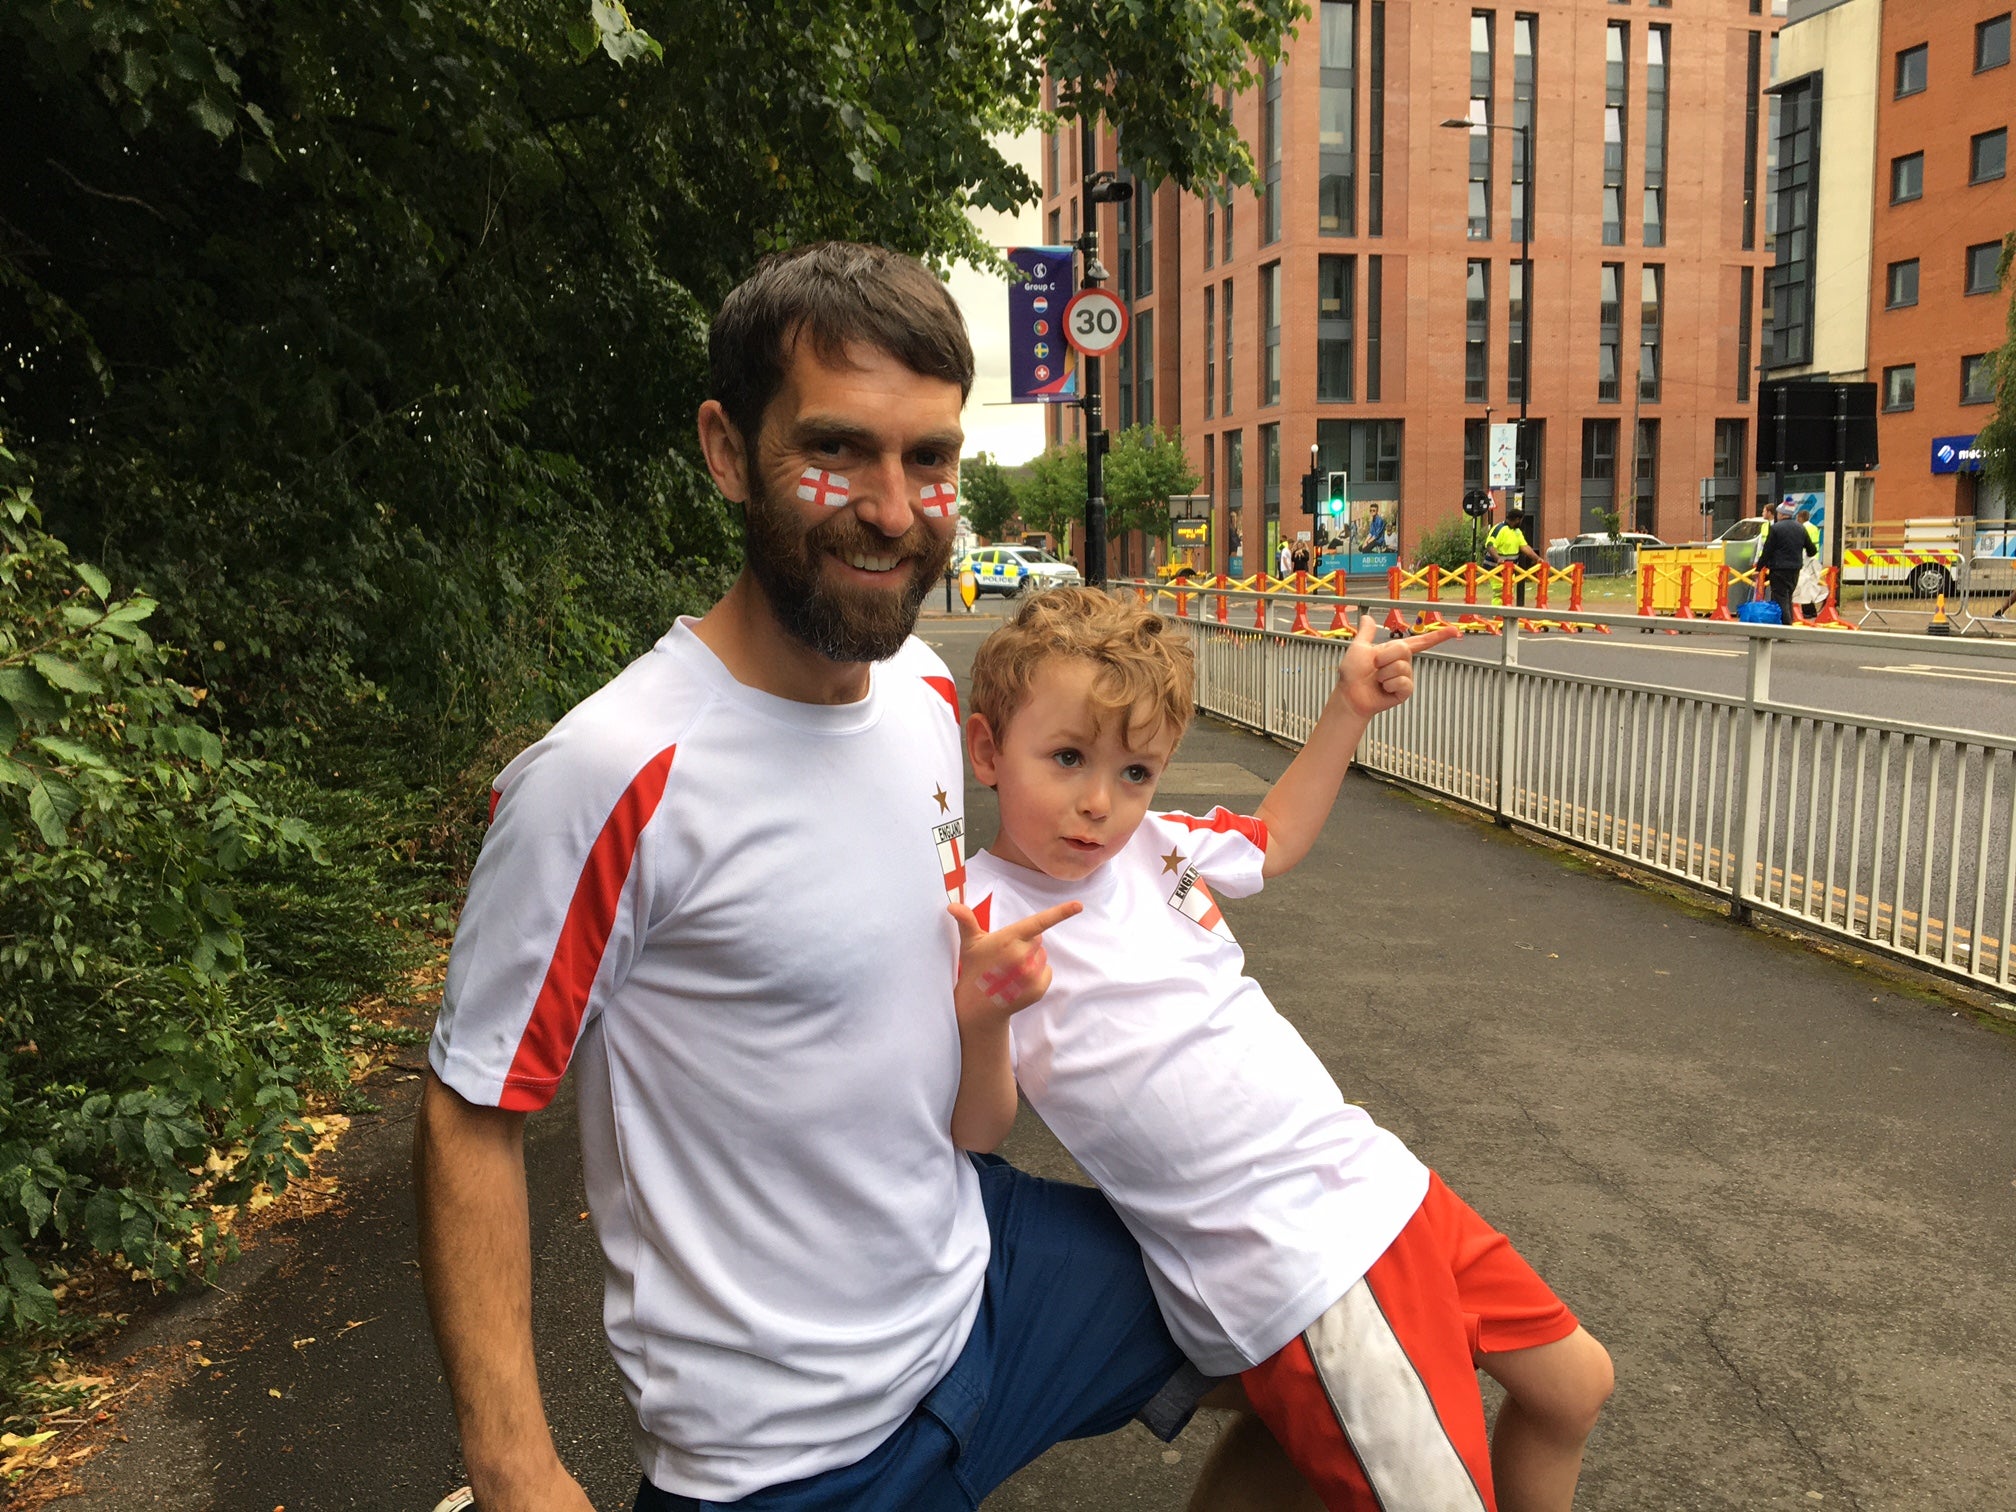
[{"left": 970, "top": 587, "right": 1195, "bottom": 740}]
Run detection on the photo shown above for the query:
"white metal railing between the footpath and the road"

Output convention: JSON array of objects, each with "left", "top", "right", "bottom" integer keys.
[{"left": 1153, "top": 585, "right": 2016, "bottom": 990}]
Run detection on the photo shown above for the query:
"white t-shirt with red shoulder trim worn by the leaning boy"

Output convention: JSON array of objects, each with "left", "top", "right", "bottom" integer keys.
[{"left": 966, "top": 808, "right": 1427, "bottom": 1375}]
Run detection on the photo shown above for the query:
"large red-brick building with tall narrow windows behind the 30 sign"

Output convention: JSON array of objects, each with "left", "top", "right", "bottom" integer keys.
[{"left": 1044, "top": 0, "right": 1780, "bottom": 571}]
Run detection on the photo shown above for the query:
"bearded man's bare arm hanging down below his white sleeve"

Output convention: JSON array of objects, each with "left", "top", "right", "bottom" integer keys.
[{"left": 413, "top": 1070, "right": 591, "bottom": 1512}]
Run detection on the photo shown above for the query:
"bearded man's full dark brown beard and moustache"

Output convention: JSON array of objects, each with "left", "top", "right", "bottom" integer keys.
[{"left": 742, "top": 478, "right": 952, "bottom": 661}]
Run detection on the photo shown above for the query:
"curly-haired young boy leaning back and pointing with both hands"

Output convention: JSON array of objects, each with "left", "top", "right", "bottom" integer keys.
[{"left": 952, "top": 589, "right": 1611, "bottom": 1512}]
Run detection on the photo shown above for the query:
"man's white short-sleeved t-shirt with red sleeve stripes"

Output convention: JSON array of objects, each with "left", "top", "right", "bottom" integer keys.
[{"left": 429, "top": 621, "right": 988, "bottom": 1502}]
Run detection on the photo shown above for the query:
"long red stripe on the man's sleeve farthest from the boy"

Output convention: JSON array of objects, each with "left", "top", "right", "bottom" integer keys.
[{"left": 498, "top": 746, "right": 677, "bottom": 1113}]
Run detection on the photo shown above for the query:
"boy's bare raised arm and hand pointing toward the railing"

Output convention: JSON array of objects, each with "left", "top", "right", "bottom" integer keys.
[{"left": 1258, "top": 613, "right": 1462, "bottom": 877}]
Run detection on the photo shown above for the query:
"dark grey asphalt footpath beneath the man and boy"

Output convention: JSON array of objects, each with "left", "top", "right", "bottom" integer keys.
[{"left": 65, "top": 617, "right": 2016, "bottom": 1512}]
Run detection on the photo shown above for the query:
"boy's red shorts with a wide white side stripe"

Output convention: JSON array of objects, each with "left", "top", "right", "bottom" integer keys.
[{"left": 1240, "top": 1173, "right": 1577, "bottom": 1512}]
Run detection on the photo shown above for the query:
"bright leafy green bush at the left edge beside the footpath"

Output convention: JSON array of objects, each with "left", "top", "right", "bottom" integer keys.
[{"left": 0, "top": 459, "right": 334, "bottom": 1335}]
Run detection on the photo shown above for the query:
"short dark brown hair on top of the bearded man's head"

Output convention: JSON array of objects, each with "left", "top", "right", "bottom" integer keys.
[{"left": 708, "top": 242, "right": 974, "bottom": 446}]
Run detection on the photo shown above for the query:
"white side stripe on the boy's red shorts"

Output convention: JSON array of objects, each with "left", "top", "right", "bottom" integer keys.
[{"left": 1302, "top": 1278, "right": 1484, "bottom": 1512}]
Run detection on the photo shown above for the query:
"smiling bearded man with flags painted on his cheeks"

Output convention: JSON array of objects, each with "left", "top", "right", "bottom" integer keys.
[{"left": 415, "top": 244, "right": 1233, "bottom": 1512}]
